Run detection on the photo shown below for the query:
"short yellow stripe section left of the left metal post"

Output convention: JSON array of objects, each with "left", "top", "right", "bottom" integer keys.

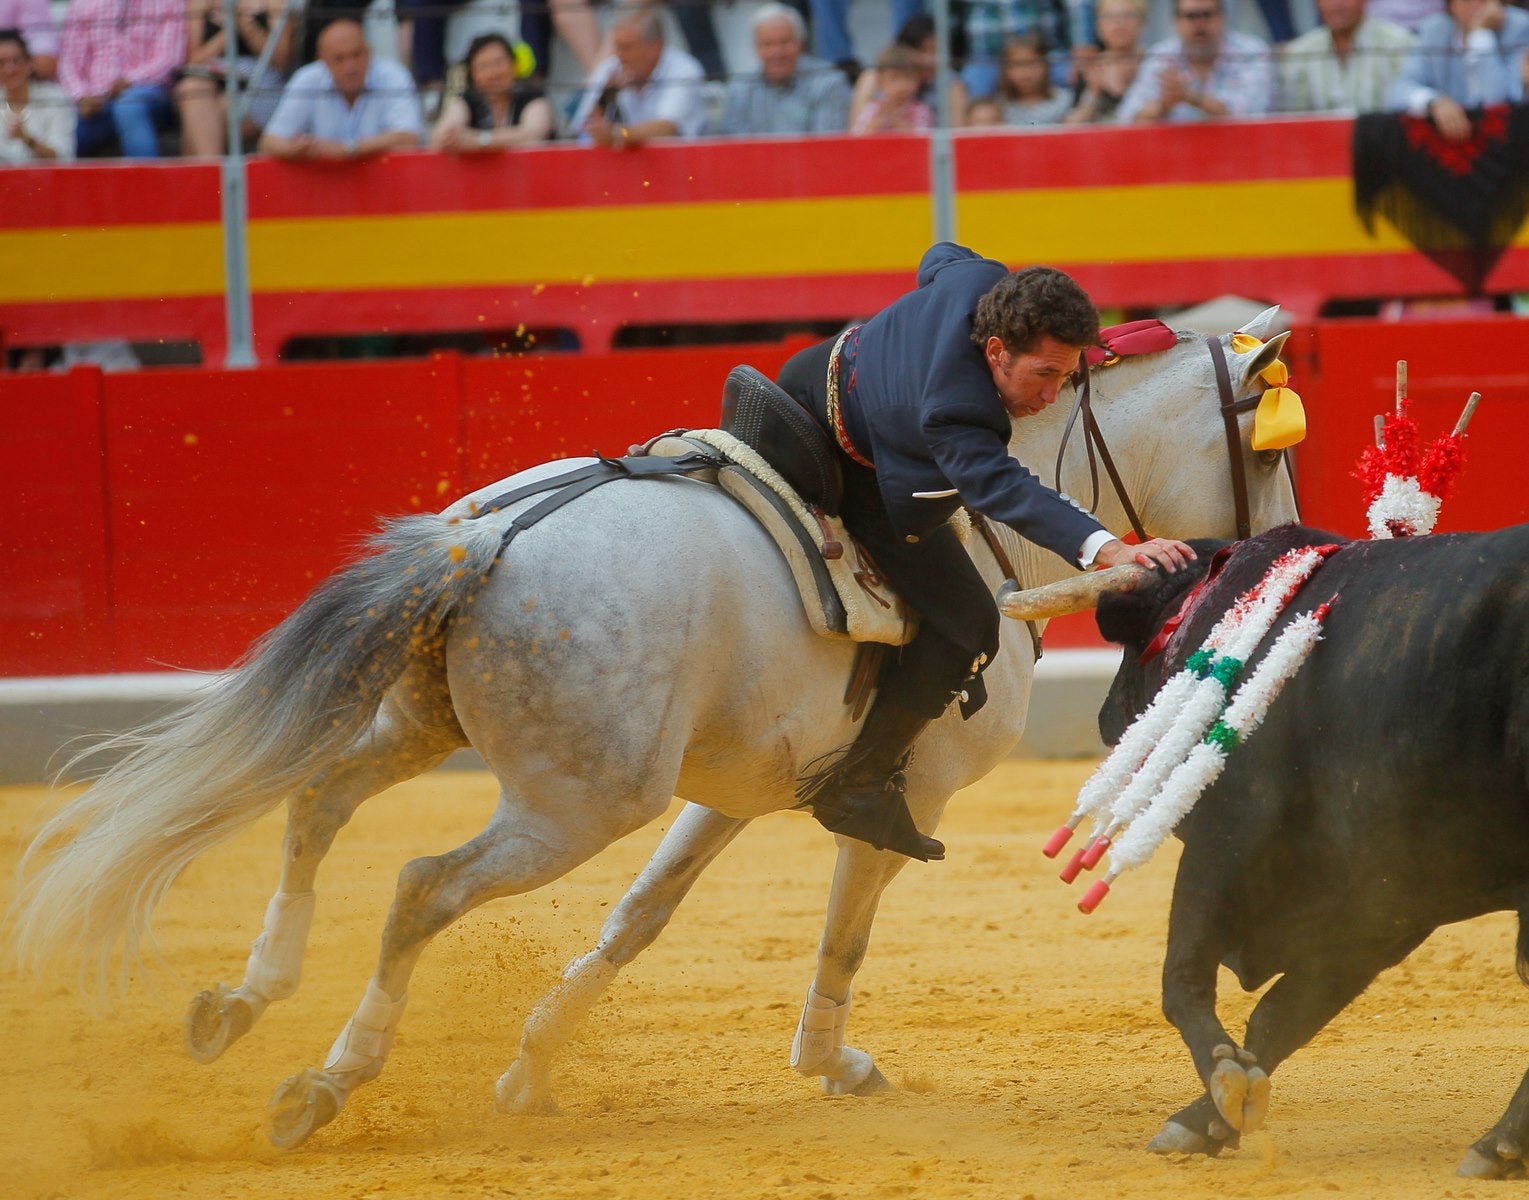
[{"left": 0, "top": 222, "right": 223, "bottom": 304}]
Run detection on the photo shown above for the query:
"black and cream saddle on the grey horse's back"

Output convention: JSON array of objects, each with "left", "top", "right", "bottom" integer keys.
[{"left": 631, "top": 367, "right": 917, "bottom": 645}]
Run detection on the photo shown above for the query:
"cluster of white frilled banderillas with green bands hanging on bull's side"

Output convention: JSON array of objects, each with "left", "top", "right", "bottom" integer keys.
[{"left": 1044, "top": 546, "right": 1338, "bottom": 913}]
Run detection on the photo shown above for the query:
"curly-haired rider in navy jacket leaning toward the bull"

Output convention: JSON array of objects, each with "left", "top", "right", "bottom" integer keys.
[{"left": 778, "top": 242, "right": 1194, "bottom": 862}]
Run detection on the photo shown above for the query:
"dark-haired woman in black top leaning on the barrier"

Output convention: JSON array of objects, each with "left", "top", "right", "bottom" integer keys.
[{"left": 430, "top": 34, "right": 552, "bottom": 154}]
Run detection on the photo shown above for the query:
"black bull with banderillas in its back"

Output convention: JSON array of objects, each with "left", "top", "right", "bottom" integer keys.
[{"left": 1098, "top": 524, "right": 1529, "bottom": 1179}]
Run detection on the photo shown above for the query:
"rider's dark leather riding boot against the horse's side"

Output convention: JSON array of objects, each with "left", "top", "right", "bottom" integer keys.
[{"left": 812, "top": 699, "right": 945, "bottom": 862}]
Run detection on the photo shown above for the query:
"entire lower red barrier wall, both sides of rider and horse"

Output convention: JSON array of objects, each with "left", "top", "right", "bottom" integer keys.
[{"left": 0, "top": 316, "right": 1529, "bottom": 676}]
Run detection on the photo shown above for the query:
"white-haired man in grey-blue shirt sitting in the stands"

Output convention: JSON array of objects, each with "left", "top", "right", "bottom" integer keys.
[{"left": 722, "top": 3, "right": 850, "bottom": 135}]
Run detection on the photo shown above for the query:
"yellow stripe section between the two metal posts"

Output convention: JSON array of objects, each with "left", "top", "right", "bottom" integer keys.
[{"left": 249, "top": 196, "right": 931, "bottom": 292}]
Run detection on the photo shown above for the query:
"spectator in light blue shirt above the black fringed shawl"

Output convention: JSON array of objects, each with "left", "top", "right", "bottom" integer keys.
[{"left": 1390, "top": 0, "right": 1529, "bottom": 141}]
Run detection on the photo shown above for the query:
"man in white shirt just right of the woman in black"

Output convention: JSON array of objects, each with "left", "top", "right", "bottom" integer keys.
[{"left": 572, "top": 6, "right": 706, "bottom": 150}]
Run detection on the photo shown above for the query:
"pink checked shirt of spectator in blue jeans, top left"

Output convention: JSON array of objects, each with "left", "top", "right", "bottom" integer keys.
[{"left": 58, "top": 0, "right": 187, "bottom": 101}]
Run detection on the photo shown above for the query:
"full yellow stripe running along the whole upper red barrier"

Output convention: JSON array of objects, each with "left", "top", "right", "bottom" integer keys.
[{"left": 14, "top": 177, "right": 1529, "bottom": 304}]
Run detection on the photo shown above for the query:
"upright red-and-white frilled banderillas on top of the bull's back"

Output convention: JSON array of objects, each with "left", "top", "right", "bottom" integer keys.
[{"left": 1355, "top": 361, "right": 1482, "bottom": 538}]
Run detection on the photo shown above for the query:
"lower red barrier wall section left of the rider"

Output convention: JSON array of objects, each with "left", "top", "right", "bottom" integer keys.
[{"left": 0, "top": 342, "right": 801, "bottom": 676}]
